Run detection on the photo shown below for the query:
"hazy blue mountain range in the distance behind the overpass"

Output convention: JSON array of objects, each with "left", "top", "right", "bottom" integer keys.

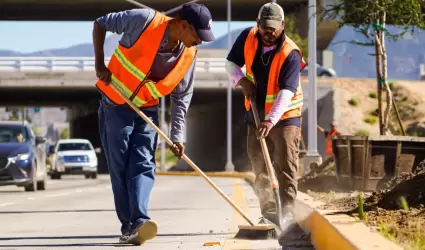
[{"left": 0, "top": 25, "right": 425, "bottom": 80}]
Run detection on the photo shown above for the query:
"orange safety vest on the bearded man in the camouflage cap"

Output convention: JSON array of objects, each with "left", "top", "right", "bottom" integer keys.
[{"left": 244, "top": 27, "right": 306, "bottom": 120}]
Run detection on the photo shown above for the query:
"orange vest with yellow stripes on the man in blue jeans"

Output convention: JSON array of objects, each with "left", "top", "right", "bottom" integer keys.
[{"left": 96, "top": 12, "right": 197, "bottom": 107}]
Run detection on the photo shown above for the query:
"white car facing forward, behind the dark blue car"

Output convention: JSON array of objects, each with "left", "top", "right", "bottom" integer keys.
[{"left": 49, "top": 139, "right": 97, "bottom": 179}]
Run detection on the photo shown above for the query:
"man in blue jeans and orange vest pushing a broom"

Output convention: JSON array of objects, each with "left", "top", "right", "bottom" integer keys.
[{"left": 93, "top": 3, "right": 215, "bottom": 245}]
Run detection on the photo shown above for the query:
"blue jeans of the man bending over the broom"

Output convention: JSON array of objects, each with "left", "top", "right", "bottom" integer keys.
[{"left": 98, "top": 97, "right": 158, "bottom": 234}]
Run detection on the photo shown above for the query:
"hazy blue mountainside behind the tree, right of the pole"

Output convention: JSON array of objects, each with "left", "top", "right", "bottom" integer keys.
[{"left": 328, "top": 25, "right": 425, "bottom": 80}]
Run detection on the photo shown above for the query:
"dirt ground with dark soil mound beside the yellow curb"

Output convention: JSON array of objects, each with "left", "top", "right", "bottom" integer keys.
[{"left": 300, "top": 168, "right": 425, "bottom": 250}]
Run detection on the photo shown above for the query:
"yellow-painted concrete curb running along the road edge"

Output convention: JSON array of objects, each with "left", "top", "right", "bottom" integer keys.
[{"left": 156, "top": 171, "right": 403, "bottom": 250}]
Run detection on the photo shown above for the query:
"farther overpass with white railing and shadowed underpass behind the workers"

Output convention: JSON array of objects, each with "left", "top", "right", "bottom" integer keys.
[{"left": 0, "top": 57, "right": 334, "bottom": 171}]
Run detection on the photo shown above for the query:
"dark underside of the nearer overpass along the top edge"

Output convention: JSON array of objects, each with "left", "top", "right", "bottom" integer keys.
[{"left": 0, "top": 0, "right": 338, "bottom": 51}]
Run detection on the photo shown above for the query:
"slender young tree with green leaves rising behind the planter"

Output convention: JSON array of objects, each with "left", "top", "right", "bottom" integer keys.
[{"left": 321, "top": 0, "right": 425, "bottom": 135}]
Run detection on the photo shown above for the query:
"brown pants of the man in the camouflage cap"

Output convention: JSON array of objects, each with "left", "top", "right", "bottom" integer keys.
[{"left": 247, "top": 125, "right": 300, "bottom": 221}]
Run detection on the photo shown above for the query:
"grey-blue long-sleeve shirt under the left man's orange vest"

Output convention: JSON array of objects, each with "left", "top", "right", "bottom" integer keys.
[{"left": 96, "top": 9, "right": 196, "bottom": 142}]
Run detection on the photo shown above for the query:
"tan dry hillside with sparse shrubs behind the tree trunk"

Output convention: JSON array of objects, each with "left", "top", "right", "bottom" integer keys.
[{"left": 308, "top": 78, "right": 425, "bottom": 136}]
